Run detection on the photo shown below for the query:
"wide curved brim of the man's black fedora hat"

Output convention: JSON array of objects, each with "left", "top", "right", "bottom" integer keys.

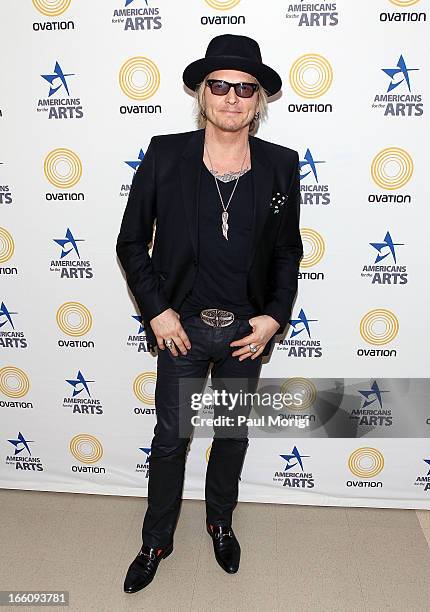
[{"left": 182, "top": 55, "right": 282, "bottom": 96}]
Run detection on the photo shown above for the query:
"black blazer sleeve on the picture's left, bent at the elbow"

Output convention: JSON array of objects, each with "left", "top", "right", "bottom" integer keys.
[{"left": 116, "top": 138, "right": 171, "bottom": 321}]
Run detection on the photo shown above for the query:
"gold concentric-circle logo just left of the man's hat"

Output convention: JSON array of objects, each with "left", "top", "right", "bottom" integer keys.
[{"left": 119, "top": 57, "right": 160, "bottom": 100}]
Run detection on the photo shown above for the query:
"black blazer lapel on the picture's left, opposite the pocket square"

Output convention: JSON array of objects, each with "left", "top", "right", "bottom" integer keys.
[{"left": 180, "top": 129, "right": 205, "bottom": 258}]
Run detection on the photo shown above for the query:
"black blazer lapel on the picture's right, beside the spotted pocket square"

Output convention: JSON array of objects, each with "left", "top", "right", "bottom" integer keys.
[{"left": 247, "top": 136, "right": 274, "bottom": 269}]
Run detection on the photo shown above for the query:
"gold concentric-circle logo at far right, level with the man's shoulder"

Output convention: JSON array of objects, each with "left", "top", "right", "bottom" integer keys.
[{"left": 371, "top": 147, "right": 414, "bottom": 189}]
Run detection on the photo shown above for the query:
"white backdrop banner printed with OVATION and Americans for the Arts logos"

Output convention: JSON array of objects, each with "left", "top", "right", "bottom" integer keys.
[{"left": 0, "top": 0, "right": 430, "bottom": 508}]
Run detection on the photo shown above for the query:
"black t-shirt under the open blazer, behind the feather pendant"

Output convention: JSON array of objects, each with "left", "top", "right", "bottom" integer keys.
[{"left": 179, "top": 163, "right": 257, "bottom": 319}]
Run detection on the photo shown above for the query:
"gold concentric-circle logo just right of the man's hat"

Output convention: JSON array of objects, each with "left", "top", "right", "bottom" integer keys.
[{"left": 290, "top": 53, "right": 333, "bottom": 98}]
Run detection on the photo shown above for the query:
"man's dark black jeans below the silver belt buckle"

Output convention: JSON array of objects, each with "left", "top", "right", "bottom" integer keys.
[{"left": 142, "top": 315, "right": 262, "bottom": 547}]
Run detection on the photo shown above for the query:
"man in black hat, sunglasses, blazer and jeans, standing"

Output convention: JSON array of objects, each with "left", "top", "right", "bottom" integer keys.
[{"left": 117, "top": 34, "right": 303, "bottom": 593}]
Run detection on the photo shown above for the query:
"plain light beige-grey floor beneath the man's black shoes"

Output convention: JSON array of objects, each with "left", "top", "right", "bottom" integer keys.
[{"left": 0, "top": 489, "right": 430, "bottom": 612}]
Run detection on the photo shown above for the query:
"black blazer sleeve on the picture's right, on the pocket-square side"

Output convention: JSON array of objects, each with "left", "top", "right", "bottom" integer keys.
[{"left": 263, "top": 153, "right": 303, "bottom": 334}]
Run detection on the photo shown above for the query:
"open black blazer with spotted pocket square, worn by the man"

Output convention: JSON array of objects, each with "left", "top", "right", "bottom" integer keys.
[{"left": 116, "top": 129, "right": 303, "bottom": 355}]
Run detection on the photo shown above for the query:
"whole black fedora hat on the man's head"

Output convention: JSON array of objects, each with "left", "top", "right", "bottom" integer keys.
[{"left": 182, "top": 34, "right": 282, "bottom": 96}]
